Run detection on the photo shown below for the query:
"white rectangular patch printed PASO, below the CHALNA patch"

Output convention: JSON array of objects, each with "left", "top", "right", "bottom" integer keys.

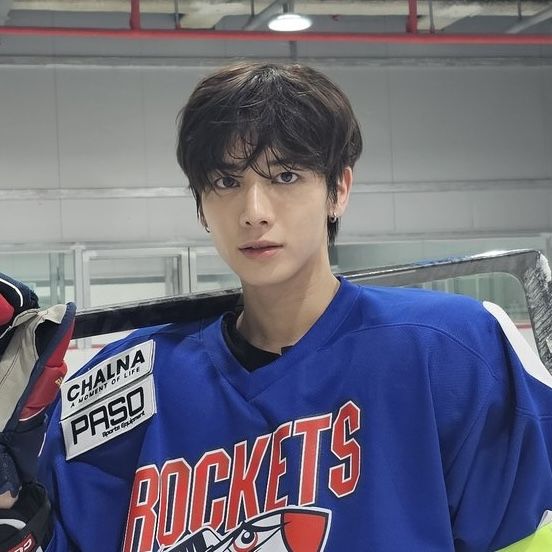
[{"left": 60, "top": 374, "right": 157, "bottom": 460}]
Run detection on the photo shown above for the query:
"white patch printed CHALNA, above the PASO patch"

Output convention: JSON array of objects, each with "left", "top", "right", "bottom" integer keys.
[{"left": 61, "top": 339, "right": 154, "bottom": 420}]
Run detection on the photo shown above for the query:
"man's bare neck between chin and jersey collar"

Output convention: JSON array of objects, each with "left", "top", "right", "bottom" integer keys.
[{"left": 237, "top": 265, "right": 339, "bottom": 353}]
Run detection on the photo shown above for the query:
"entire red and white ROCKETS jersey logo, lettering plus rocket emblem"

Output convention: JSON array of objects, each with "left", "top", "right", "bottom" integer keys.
[{"left": 122, "top": 401, "right": 361, "bottom": 552}]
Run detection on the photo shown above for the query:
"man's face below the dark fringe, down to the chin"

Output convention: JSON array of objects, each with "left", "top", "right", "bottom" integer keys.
[{"left": 202, "top": 155, "right": 331, "bottom": 286}]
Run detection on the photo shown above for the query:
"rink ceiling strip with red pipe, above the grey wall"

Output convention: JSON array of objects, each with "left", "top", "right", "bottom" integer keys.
[{"left": 0, "top": 0, "right": 552, "bottom": 63}]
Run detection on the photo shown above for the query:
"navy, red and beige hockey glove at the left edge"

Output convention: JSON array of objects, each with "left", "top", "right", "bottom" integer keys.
[{"left": 0, "top": 273, "right": 75, "bottom": 497}]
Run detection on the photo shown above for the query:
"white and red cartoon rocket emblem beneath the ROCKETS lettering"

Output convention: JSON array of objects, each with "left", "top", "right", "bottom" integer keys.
[{"left": 165, "top": 508, "right": 330, "bottom": 552}]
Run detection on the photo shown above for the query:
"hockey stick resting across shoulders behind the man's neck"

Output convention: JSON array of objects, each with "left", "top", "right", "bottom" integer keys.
[{"left": 73, "top": 249, "right": 552, "bottom": 370}]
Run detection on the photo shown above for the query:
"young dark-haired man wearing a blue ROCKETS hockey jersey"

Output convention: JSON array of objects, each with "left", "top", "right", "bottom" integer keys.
[{"left": 4, "top": 63, "right": 552, "bottom": 552}]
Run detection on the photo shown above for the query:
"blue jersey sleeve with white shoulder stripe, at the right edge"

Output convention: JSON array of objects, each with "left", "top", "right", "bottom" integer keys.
[{"left": 444, "top": 303, "right": 552, "bottom": 552}]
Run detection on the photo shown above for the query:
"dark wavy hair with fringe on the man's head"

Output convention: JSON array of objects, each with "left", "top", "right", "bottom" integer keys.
[{"left": 176, "top": 62, "right": 362, "bottom": 244}]
